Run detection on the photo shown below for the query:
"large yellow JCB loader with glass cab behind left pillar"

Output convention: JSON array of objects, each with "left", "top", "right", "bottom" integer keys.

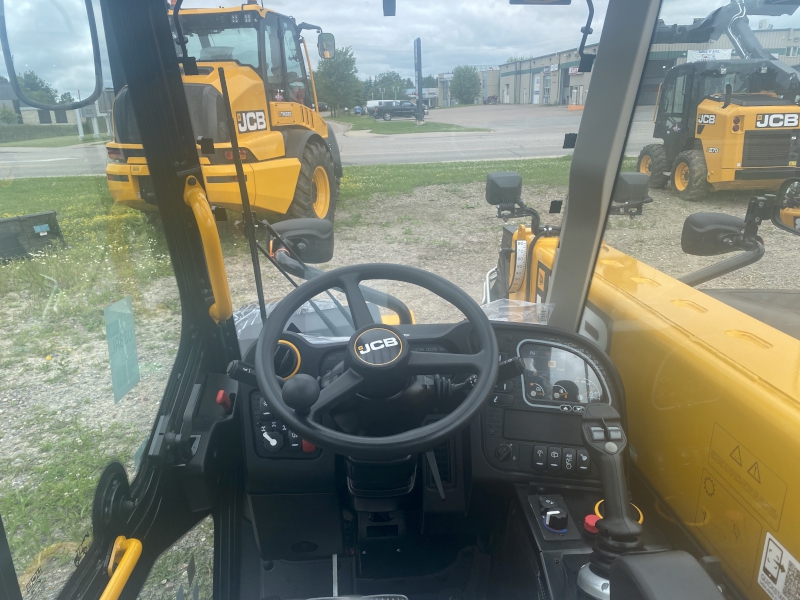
[{"left": 106, "top": 2, "right": 342, "bottom": 220}]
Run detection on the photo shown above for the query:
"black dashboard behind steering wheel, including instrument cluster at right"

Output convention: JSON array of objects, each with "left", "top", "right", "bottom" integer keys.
[{"left": 239, "top": 322, "right": 625, "bottom": 485}]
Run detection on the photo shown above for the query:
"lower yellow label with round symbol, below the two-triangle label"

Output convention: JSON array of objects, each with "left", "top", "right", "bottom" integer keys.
[{"left": 694, "top": 469, "right": 761, "bottom": 588}]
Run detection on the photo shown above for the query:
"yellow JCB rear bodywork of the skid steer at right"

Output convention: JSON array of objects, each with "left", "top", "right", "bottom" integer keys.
[{"left": 695, "top": 94, "right": 800, "bottom": 190}]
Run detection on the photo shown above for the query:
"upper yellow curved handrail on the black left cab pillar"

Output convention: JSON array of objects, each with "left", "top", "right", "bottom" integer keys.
[{"left": 183, "top": 177, "right": 233, "bottom": 323}]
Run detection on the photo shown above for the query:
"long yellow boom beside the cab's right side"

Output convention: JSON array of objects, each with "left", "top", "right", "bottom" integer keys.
[{"left": 500, "top": 226, "right": 800, "bottom": 600}]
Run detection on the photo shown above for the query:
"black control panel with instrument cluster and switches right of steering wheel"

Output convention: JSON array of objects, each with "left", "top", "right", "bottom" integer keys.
[{"left": 482, "top": 323, "right": 621, "bottom": 480}]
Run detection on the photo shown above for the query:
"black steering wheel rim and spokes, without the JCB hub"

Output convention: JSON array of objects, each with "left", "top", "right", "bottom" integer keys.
[{"left": 255, "top": 263, "right": 499, "bottom": 459}]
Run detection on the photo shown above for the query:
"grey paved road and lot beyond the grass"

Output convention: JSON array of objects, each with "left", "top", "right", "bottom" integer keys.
[{"left": 0, "top": 105, "right": 653, "bottom": 179}]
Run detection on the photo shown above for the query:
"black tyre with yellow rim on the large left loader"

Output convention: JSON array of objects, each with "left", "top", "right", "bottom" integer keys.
[{"left": 286, "top": 142, "right": 339, "bottom": 221}]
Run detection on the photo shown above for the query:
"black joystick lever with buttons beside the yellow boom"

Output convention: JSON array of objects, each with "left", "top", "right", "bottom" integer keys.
[{"left": 578, "top": 404, "right": 643, "bottom": 598}]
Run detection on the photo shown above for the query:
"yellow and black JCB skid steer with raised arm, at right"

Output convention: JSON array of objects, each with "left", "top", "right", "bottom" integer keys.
[{"left": 638, "top": 0, "right": 800, "bottom": 200}]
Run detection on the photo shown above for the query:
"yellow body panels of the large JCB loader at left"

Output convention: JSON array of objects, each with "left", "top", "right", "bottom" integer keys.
[{"left": 106, "top": 4, "right": 328, "bottom": 214}]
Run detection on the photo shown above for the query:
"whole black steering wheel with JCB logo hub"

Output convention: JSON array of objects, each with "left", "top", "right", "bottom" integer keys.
[{"left": 256, "top": 264, "right": 498, "bottom": 459}]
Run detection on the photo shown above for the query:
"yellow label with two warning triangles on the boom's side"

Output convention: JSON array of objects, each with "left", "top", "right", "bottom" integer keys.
[{"left": 708, "top": 423, "right": 786, "bottom": 529}]
